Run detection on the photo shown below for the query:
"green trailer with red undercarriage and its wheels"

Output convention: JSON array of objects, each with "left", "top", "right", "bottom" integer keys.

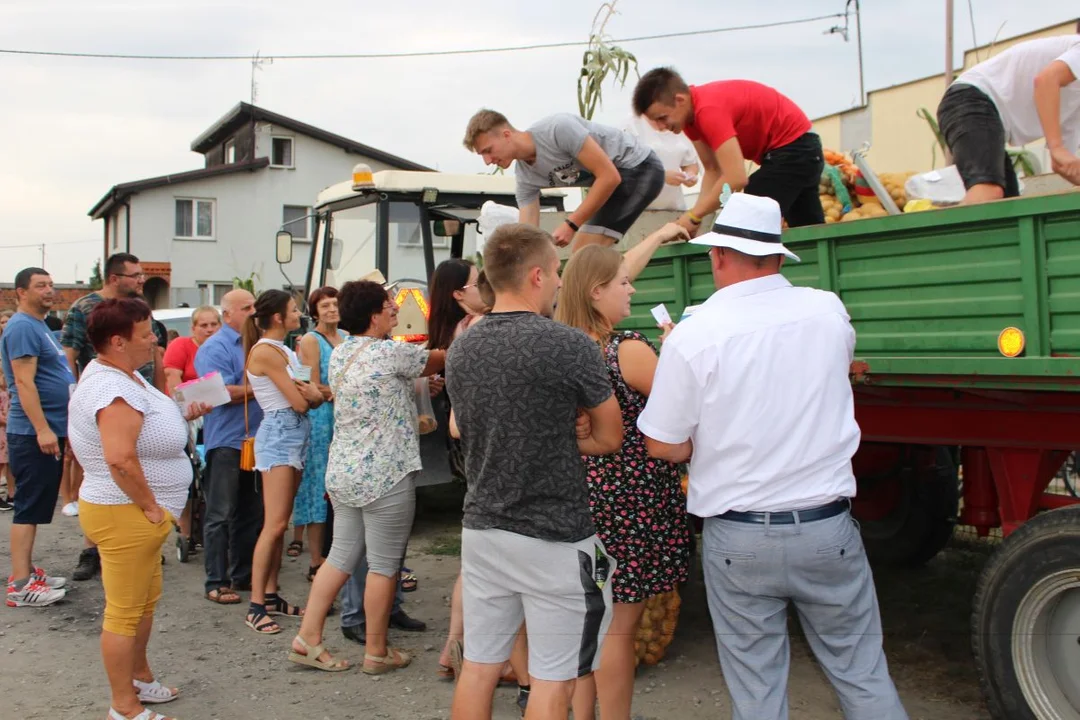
[{"left": 624, "top": 192, "right": 1080, "bottom": 720}]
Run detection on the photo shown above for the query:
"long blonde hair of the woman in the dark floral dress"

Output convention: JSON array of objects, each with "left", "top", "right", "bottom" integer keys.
[{"left": 555, "top": 245, "right": 623, "bottom": 342}]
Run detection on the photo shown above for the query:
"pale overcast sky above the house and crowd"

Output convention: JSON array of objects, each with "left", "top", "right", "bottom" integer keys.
[{"left": 0, "top": 0, "right": 1078, "bottom": 282}]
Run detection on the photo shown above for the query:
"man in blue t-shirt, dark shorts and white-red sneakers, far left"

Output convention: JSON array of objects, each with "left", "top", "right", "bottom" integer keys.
[{"left": 0, "top": 268, "right": 75, "bottom": 608}]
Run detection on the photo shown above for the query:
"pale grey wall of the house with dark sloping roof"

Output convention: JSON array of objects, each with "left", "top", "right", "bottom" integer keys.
[{"left": 110, "top": 131, "right": 406, "bottom": 305}]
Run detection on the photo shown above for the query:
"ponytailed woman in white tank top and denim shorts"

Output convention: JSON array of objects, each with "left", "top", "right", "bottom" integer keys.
[{"left": 236, "top": 290, "right": 323, "bottom": 635}]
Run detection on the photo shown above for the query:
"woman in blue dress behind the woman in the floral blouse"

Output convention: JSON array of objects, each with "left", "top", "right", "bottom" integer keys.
[{"left": 291, "top": 286, "right": 346, "bottom": 581}]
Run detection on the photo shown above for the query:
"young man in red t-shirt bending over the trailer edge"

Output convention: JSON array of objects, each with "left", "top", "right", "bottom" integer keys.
[{"left": 634, "top": 68, "right": 825, "bottom": 235}]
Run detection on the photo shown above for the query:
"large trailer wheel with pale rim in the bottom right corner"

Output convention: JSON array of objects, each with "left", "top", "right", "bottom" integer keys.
[{"left": 971, "top": 506, "right": 1080, "bottom": 720}]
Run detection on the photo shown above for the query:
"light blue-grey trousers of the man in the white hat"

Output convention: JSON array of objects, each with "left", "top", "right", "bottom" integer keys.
[{"left": 702, "top": 513, "right": 907, "bottom": 720}]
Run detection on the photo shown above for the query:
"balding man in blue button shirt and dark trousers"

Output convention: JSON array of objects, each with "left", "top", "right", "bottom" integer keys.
[{"left": 195, "top": 289, "right": 262, "bottom": 604}]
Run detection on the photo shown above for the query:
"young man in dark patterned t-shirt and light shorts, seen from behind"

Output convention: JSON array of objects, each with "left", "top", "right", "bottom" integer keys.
[{"left": 446, "top": 225, "right": 622, "bottom": 720}]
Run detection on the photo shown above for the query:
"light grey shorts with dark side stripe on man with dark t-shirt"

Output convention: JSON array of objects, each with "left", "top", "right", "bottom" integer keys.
[{"left": 461, "top": 528, "right": 615, "bottom": 682}]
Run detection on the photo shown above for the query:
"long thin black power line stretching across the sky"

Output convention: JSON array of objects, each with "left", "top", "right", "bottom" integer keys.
[{"left": 0, "top": 13, "right": 847, "bottom": 63}]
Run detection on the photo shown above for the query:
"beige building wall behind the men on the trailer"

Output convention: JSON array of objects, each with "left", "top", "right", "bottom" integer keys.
[{"left": 813, "top": 21, "right": 1077, "bottom": 173}]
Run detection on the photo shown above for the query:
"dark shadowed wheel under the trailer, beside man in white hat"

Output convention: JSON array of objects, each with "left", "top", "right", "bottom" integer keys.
[{"left": 855, "top": 446, "right": 960, "bottom": 567}]
